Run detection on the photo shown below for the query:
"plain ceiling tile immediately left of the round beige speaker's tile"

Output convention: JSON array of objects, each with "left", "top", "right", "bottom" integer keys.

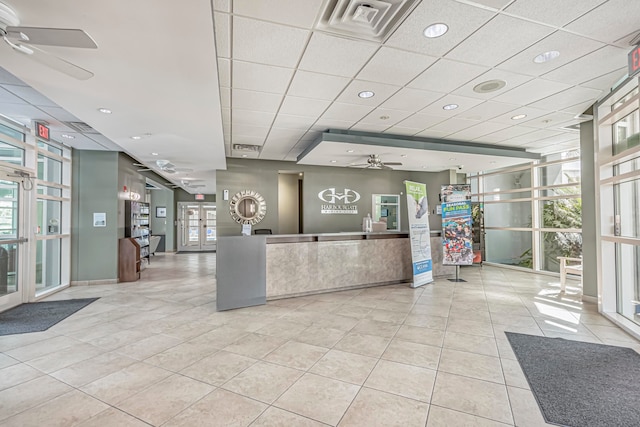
[{"left": 408, "top": 59, "right": 489, "bottom": 92}]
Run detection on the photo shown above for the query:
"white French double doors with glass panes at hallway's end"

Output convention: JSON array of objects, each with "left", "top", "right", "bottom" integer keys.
[{"left": 178, "top": 202, "right": 216, "bottom": 252}]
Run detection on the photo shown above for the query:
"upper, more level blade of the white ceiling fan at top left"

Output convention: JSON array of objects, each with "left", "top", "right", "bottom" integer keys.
[{"left": 6, "top": 27, "right": 98, "bottom": 49}]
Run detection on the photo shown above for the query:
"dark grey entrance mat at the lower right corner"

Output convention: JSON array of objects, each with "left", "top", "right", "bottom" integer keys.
[{"left": 505, "top": 332, "right": 640, "bottom": 427}]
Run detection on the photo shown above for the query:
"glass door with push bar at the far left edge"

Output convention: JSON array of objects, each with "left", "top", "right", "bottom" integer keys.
[{"left": 0, "top": 176, "right": 27, "bottom": 311}]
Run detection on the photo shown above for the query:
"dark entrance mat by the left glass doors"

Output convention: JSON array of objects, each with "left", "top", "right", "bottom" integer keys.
[{"left": 0, "top": 298, "right": 98, "bottom": 335}]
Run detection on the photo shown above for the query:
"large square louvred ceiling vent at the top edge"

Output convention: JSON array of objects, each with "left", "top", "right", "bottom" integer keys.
[{"left": 316, "top": 0, "right": 420, "bottom": 42}]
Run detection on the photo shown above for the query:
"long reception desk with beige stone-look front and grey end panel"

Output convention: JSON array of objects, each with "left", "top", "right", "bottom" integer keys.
[{"left": 217, "top": 232, "right": 455, "bottom": 310}]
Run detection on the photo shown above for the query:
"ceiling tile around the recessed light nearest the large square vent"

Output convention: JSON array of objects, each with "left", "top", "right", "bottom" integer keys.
[{"left": 386, "top": 0, "right": 495, "bottom": 56}]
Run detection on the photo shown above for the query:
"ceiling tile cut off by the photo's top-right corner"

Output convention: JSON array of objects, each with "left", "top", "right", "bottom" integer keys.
[{"left": 566, "top": 0, "right": 640, "bottom": 43}]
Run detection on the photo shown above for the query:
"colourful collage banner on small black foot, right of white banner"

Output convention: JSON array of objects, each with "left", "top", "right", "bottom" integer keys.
[{"left": 441, "top": 184, "right": 473, "bottom": 282}]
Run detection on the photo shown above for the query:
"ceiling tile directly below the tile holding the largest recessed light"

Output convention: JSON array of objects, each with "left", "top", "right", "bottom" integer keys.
[{"left": 357, "top": 47, "right": 437, "bottom": 86}]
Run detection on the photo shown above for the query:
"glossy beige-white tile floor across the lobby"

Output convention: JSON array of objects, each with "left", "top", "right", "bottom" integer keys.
[{"left": 0, "top": 253, "right": 640, "bottom": 427}]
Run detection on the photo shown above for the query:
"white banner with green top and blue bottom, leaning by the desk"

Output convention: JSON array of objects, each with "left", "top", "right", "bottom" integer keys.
[{"left": 405, "top": 181, "right": 433, "bottom": 288}]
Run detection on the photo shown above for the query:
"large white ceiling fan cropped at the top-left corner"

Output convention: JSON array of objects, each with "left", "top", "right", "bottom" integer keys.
[{"left": 0, "top": 2, "right": 98, "bottom": 80}]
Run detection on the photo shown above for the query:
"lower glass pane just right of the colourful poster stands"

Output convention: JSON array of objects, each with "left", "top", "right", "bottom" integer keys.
[{"left": 485, "top": 231, "right": 533, "bottom": 268}]
